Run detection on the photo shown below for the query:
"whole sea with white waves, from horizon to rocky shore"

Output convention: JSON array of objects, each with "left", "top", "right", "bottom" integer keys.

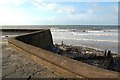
[{"left": 1, "top": 25, "right": 118, "bottom": 53}]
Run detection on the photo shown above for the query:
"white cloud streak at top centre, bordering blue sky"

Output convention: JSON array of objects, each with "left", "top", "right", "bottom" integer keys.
[{"left": 32, "top": 0, "right": 77, "bottom": 14}]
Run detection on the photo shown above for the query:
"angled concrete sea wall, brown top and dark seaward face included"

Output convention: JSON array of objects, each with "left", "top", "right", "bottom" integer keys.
[{"left": 8, "top": 29, "right": 118, "bottom": 78}]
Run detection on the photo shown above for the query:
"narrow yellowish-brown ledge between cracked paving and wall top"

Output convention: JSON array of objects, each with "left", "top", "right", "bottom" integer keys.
[{"left": 11, "top": 44, "right": 83, "bottom": 78}]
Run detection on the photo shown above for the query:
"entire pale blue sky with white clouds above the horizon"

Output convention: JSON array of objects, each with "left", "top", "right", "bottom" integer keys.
[{"left": 0, "top": 0, "right": 118, "bottom": 25}]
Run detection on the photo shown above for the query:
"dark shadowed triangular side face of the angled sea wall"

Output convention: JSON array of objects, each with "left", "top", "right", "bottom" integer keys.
[{"left": 16, "top": 30, "right": 53, "bottom": 49}]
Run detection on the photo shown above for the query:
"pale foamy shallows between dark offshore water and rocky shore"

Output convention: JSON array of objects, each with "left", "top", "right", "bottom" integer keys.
[{"left": 51, "top": 28, "right": 118, "bottom": 53}]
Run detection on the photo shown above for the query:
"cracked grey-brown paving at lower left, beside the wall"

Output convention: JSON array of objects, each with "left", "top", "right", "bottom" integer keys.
[{"left": 2, "top": 39, "right": 63, "bottom": 78}]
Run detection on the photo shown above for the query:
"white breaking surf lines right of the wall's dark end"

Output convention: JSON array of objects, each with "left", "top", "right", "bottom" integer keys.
[{"left": 51, "top": 29, "right": 118, "bottom": 42}]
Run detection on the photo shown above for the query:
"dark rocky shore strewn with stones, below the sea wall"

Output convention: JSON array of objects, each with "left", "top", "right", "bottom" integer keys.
[{"left": 53, "top": 44, "right": 120, "bottom": 72}]
